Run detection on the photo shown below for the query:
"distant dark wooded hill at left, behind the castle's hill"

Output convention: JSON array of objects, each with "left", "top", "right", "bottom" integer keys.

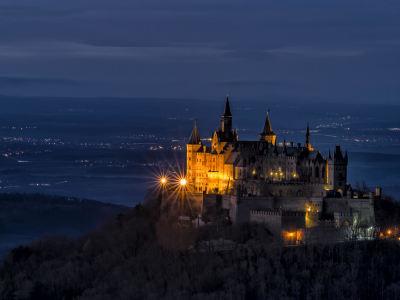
[{"left": 0, "top": 193, "right": 128, "bottom": 255}]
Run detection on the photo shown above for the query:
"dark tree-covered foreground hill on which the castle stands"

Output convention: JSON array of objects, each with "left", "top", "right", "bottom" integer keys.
[{"left": 0, "top": 199, "right": 400, "bottom": 300}]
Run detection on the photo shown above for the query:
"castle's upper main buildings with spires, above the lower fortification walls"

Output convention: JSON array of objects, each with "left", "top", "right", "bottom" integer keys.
[{"left": 187, "top": 97, "right": 348, "bottom": 197}]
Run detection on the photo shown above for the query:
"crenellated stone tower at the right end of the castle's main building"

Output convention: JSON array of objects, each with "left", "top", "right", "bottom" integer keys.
[{"left": 327, "top": 145, "right": 348, "bottom": 196}]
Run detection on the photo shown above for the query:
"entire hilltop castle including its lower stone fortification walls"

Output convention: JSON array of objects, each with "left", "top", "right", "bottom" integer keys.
[{"left": 179, "top": 97, "right": 381, "bottom": 244}]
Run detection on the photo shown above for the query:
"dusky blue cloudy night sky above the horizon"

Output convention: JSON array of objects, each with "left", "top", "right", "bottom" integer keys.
[{"left": 0, "top": 0, "right": 400, "bottom": 103}]
